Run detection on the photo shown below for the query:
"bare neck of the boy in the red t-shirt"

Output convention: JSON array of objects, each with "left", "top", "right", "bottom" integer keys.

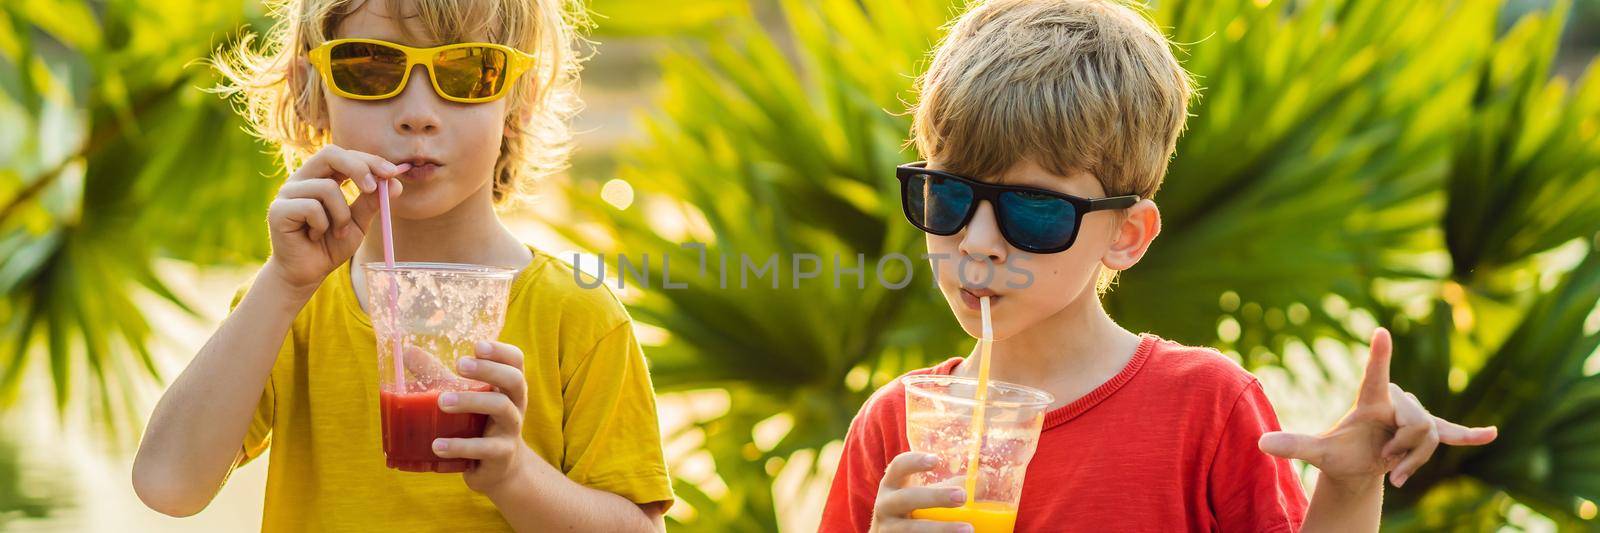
[{"left": 952, "top": 272, "right": 1141, "bottom": 408}]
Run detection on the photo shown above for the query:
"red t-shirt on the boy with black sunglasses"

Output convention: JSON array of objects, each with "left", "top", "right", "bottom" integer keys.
[{"left": 821, "top": 335, "right": 1306, "bottom": 531}]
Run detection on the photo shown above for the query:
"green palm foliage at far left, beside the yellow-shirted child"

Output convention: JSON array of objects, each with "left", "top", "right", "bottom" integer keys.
[{"left": 0, "top": 0, "right": 274, "bottom": 431}]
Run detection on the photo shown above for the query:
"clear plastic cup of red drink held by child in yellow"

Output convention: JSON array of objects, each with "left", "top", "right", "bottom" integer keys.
[{"left": 363, "top": 262, "right": 517, "bottom": 472}]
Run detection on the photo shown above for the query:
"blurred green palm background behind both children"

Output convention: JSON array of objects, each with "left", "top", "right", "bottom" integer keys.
[{"left": 0, "top": 0, "right": 1600, "bottom": 531}]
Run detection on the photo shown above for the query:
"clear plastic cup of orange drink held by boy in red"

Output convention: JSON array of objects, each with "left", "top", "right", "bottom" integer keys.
[{"left": 901, "top": 375, "right": 1054, "bottom": 533}]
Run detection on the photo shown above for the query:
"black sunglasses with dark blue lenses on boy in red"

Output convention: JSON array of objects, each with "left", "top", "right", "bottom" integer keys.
[{"left": 894, "top": 162, "right": 1139, "bottom": 253}]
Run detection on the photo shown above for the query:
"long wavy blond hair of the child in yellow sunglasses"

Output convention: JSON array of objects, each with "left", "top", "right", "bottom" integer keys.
[{"left": 211, "top": 0, "right": 586, "bottom": 202}]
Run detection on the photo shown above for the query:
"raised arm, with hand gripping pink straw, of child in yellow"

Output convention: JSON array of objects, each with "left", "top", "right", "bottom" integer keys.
[{"left": 133, "top": 144, "right": 410, "bottom": 517}]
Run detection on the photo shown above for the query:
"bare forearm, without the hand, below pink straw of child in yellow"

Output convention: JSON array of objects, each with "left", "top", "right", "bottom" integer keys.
[{"left": 133, "top": 261, "right": 310, "bottom": 517}]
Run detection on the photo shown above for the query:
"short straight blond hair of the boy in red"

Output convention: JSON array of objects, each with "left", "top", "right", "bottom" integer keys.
[{"left": 912, "top": 0, "right": 1192, "bottom": 198}]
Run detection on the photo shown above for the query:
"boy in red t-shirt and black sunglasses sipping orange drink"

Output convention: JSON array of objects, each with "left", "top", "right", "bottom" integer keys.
[{"left": 821, "top": 0, "right": 1496, "bottom": 531}]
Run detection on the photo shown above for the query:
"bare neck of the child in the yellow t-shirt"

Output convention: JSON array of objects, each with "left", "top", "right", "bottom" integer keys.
[{"left": 355, "top": 186, "right": 533, "bottom": 269}]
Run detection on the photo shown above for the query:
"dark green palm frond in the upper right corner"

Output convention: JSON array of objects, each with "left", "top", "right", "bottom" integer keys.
[{"left": 1445, "top": 3, "right": 1600, "bottom": 281}]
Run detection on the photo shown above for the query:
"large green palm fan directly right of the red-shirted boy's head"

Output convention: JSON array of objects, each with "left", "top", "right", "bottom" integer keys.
[{"left": 1106, "top": 2, "right": 1498, "bottom": 356}]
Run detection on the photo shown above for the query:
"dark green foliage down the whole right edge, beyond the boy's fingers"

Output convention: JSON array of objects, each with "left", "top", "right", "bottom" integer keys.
[{"left": 1386, "top": 10, "right": 1600, "bottom": 523}]
